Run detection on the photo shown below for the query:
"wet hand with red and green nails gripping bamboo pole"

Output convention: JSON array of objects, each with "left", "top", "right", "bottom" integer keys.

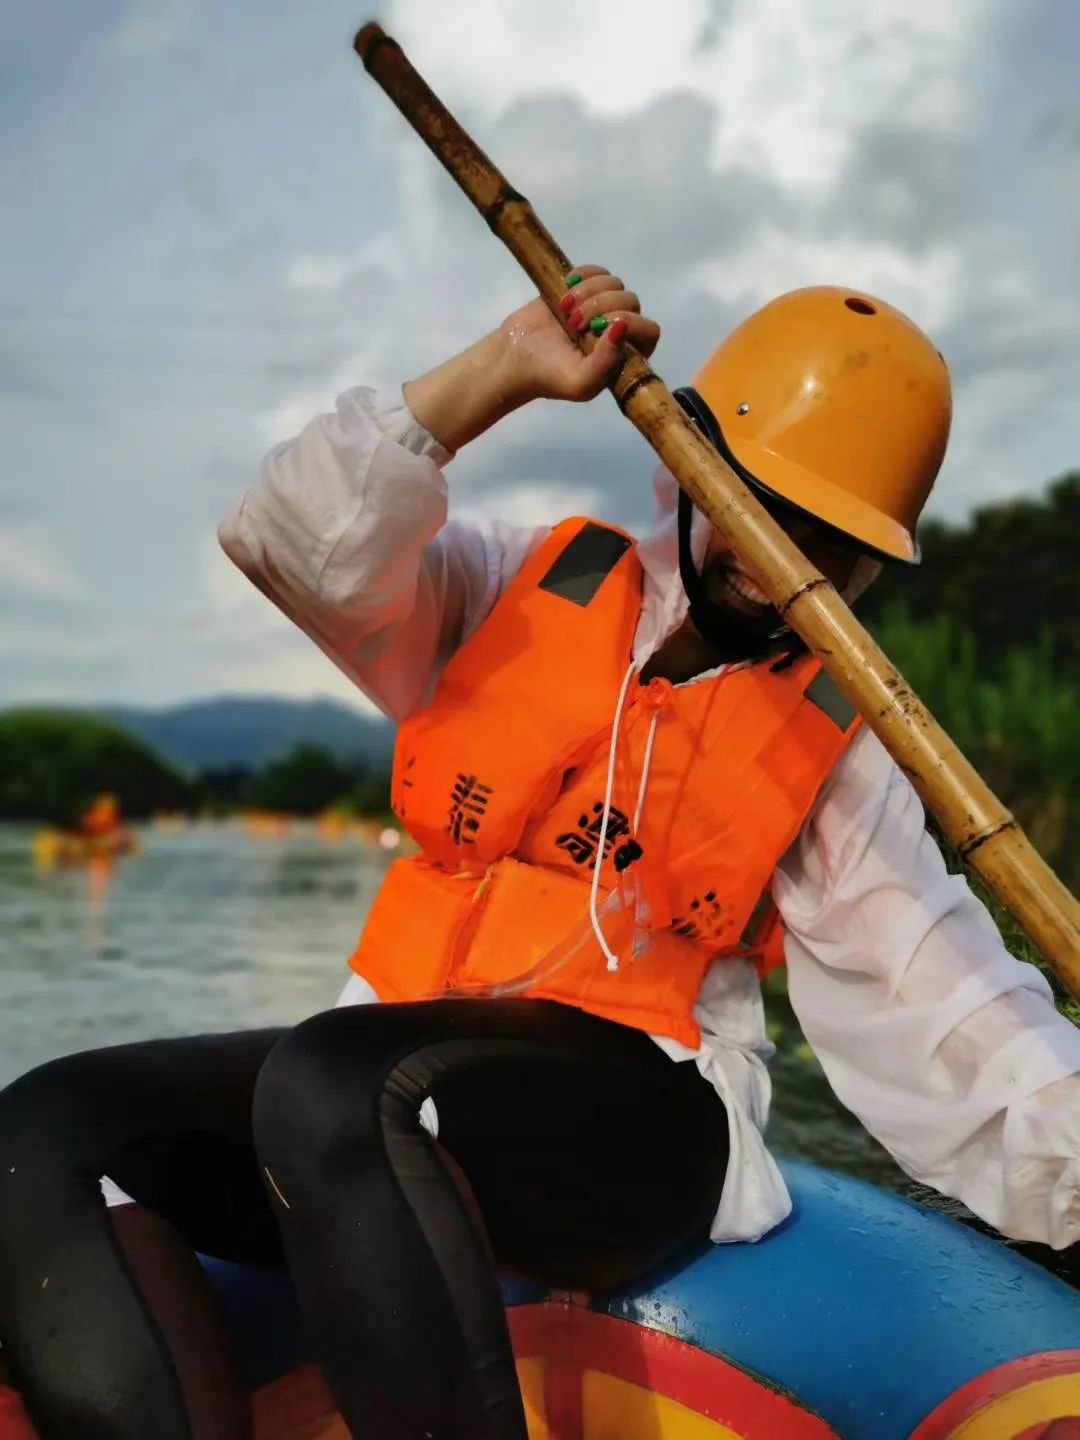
[{"left": 498, "top": 265, "right": 660, "bottom": 400}]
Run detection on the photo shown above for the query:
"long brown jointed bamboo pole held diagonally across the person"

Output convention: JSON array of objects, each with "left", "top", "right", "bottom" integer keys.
[{"left": 354, "top": 23, "right": 1080, "bottom": 998}]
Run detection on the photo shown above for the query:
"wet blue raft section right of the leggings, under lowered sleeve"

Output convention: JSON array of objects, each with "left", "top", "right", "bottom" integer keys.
[{"left": 593, "top": 1162, "right": 1080, "bottom": 1440}]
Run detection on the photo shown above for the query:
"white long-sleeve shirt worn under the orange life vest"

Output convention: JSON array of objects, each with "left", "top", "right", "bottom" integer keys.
[{"left": 220, "top": 389, "right": 1080, "bottom": 1248}]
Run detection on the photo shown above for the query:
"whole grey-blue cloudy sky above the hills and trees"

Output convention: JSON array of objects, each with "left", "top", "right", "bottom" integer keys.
[{"left": 0, "top": 0, "right": 1080, "bottom": 704}]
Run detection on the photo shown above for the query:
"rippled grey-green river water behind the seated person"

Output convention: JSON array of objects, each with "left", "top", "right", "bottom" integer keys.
[{"left": 0, "top": 822, "right": 1080, "bottom": 1283}]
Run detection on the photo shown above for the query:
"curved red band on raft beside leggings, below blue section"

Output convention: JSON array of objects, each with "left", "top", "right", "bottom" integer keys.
[{"left": 507, "top": 1303, "right": 837, "bottom": 1440}]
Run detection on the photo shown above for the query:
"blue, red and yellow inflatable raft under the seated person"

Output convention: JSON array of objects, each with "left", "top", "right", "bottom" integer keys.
[{"left": 207, "top": 1162, "right": 1080, "bottom": 1440}]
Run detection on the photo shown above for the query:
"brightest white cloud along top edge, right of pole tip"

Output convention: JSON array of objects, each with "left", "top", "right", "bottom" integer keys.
[{"left": 387, "top": 0, "right": 994, "bottom": 186}]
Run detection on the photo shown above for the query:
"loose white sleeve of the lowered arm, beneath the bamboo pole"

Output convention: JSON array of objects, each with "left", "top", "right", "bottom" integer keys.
[{"left": 773, "top": 730, "right": 1080, "bottom": 1248}]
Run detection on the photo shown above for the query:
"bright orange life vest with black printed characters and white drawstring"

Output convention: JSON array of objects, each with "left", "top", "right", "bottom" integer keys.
[{"left": 351, "top": 518, "right": 860, "bottom": 1047}]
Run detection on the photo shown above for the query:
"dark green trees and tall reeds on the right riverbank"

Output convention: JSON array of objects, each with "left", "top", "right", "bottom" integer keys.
[{"left": 861, "top": 472, "right": 1080, "bottom": 1024}]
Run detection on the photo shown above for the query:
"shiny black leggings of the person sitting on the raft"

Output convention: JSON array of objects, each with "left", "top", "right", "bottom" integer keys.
[{"left": 0, "top": 1001, "right": 727, "bottom": 1440}]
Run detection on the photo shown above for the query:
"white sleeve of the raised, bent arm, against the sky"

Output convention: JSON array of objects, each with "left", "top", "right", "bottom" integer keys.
[{"left": 217, "top": 387, "right": 547, "bottom": 720}]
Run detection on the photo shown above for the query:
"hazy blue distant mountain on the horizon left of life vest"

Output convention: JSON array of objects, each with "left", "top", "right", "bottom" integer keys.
[{"left": 96, "top": 696, "right": 393, "bottom": 770}]
